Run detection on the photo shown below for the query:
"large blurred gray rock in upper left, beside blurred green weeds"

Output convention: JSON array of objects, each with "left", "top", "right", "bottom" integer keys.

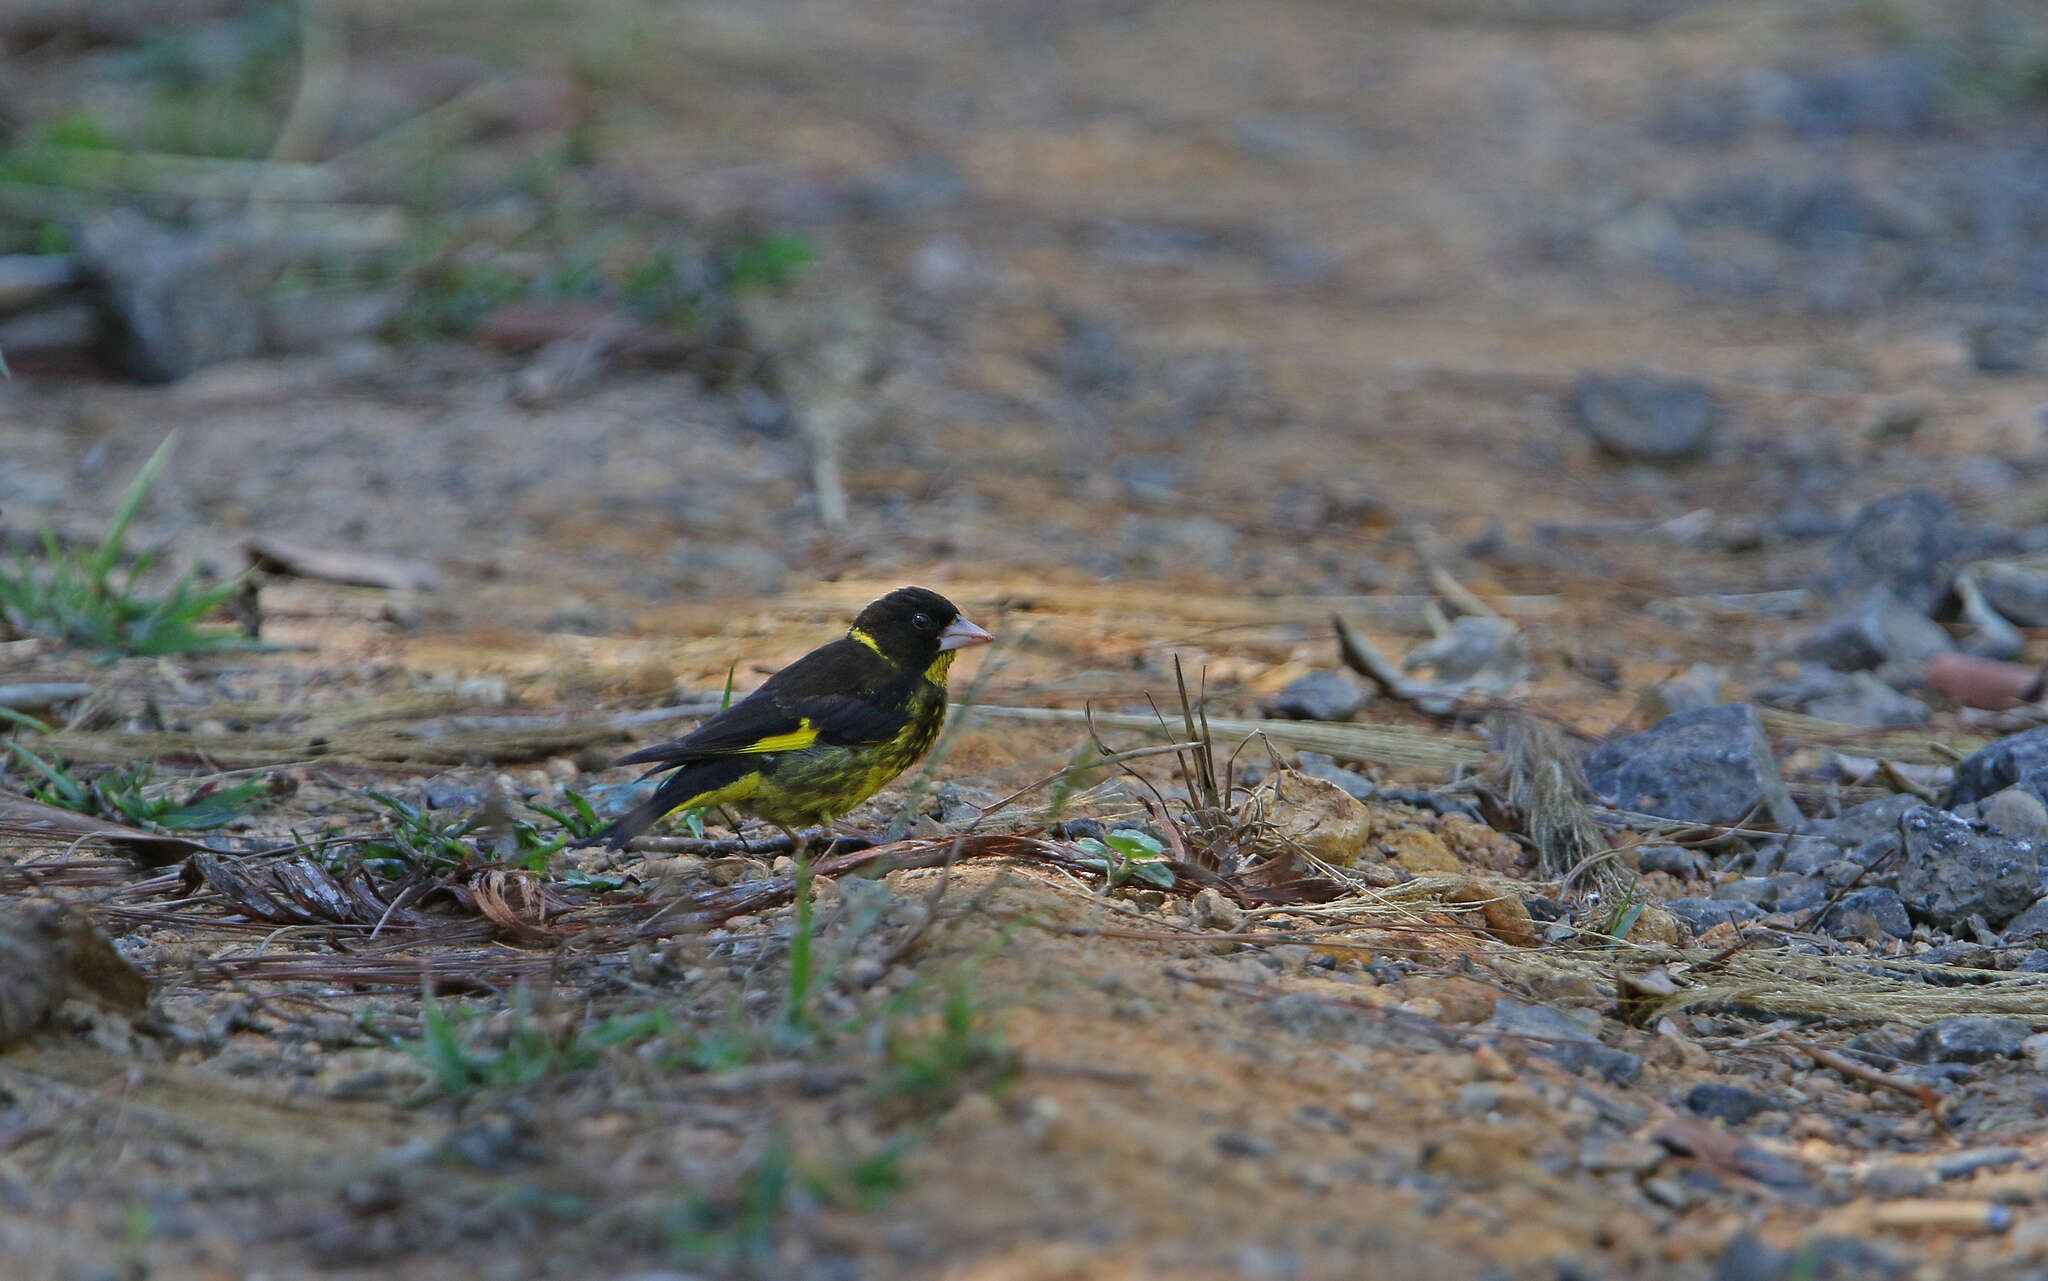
[{"left": 78, "top": 209, "right": 264, "bottom": 383}]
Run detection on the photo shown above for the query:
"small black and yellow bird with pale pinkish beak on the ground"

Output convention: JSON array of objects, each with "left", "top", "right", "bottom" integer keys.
[{"left": 580, "top": 586, "right": 993, "bottom": 859}]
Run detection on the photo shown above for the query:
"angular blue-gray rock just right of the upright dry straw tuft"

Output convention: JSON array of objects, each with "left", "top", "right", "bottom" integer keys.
[{"left": 1585, "top": 703, "right": 1800, "bottom": 828}]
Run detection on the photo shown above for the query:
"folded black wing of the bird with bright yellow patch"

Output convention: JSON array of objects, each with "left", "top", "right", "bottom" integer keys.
[{"left": 616, "top": 642, "right": 915, "bottom": 773}]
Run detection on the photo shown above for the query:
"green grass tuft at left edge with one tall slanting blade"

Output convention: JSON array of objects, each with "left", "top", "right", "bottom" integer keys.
[{"left": 0, "top": 432, "right": 250, "bottom": 656}]
